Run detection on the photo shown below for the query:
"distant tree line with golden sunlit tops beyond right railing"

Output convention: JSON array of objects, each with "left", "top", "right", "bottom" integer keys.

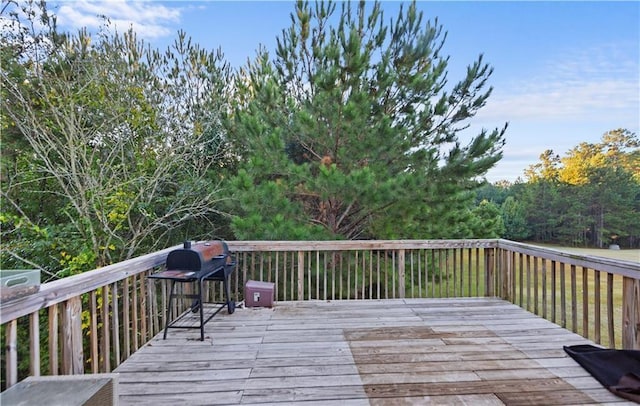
[{"left": 477, "top": 129, "right": 640, "bottom": 248}]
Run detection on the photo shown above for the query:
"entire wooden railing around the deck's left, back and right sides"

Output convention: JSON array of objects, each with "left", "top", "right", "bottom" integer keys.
[{"left": 0, "top": 240, "right": 640, "bottom": 389}]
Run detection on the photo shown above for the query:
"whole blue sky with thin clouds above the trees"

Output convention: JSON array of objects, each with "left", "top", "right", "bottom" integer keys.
[{"left": 49, "top": 0, "right": 640, "bottom": 181}]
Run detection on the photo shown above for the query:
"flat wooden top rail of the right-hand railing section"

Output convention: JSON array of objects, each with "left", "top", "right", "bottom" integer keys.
[{"left": 498, "top": 240, "right": 640, "bottom": 279}]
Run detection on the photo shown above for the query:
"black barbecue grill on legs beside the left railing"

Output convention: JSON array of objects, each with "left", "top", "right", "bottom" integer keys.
[{"left": 149, "top": 241, "right": 236, "bottom": 341}]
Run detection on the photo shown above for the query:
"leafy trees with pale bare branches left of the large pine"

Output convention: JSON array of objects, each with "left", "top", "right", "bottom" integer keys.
[{"left": 0, "top": 3, "right": 230, "bottom": 276}]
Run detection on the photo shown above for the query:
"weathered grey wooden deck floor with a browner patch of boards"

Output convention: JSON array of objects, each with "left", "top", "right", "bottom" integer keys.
[{"left": 115, "top": 298, "right": 633, "bottom": 406}]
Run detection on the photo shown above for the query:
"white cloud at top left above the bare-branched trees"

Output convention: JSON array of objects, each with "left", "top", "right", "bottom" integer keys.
[{"left": 56, "top": 0, "right": 183, "bottom": 40}]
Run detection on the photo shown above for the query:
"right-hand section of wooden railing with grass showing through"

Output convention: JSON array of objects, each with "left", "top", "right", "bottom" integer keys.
[{"left": 494, "top": 240, "right": 640, "bottom": 349}]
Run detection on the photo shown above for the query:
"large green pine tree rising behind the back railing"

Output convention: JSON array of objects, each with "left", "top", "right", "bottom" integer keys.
[{"left": 228, "top": 2, "right": 504, "bottom": 239}]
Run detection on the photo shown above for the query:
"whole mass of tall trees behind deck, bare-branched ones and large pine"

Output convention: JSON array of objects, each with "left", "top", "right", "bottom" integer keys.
[{"left": 0, "top": 1, "right": 506, "bottom": 279}]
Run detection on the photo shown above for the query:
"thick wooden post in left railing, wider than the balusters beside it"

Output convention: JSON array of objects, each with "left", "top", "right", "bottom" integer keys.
[{"left": 62, "top": 296, "right": 84, "bottom": 375}]
